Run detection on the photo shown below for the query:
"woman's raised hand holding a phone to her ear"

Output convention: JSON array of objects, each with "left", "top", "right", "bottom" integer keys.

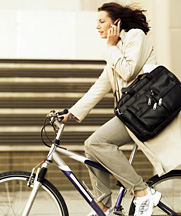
[{"left": 107, "top": 21, "right": 121, "bottom": 47}]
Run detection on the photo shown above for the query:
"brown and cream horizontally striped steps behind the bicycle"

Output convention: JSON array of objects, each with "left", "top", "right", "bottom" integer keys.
[{"left": 0, "top": 60, "right": 154, "bottom": 190}]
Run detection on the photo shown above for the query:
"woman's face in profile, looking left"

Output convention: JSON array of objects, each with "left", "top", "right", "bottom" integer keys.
[{"left": 96, "top": 11, "right": 113, "bottom": 39}]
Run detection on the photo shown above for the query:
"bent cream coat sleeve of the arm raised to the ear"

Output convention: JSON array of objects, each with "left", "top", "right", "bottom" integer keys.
[{"left": 104, "top": 29, "right": 153, "bottom": 82}]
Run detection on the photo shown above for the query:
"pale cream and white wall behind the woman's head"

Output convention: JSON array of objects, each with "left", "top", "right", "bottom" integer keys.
[{"left": 0, "top": 0, "right": 181, "bottom": 77}]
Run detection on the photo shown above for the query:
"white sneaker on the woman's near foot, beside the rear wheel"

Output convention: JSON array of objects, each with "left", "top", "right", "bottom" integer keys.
[{"left": 133, "top": 188, "right": 161, "bottom": 216}]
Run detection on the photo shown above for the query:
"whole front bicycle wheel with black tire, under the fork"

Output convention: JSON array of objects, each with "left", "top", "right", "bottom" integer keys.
[{"left": 0, "top": 171, "right": 69, "bottom": 216}]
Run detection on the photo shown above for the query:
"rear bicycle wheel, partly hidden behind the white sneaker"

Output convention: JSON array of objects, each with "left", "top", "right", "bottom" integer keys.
[{"left": 129, "top": 170, "right": 181, "bottom": 216}]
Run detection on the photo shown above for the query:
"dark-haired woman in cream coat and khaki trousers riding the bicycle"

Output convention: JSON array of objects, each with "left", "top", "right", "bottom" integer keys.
[{"left": 64, "top": 3, "right": 161, "bottom": 216}]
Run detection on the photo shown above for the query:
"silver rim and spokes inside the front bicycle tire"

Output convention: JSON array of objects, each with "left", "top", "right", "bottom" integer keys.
[{"left": 0, "top": 177, "right": 62, "bottom": 216}]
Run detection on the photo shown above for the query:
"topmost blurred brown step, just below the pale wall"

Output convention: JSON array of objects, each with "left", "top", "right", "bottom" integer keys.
[{"left": 0, "top": 60, "right": 105, "bottom": 78}]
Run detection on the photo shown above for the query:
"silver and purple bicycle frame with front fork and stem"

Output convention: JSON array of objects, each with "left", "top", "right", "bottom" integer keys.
[{"left": 22, "top": 118, "right": 177, "bottom": 216}]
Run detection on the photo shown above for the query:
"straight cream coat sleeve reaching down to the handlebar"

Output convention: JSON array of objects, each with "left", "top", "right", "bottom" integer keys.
[{"left": 69, "top": 67, "right": 111, "bottom": 122}]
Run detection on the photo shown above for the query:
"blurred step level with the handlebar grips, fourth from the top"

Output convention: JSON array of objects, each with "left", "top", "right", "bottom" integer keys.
[{"left": 0, "top": 109, "right": 114, "bottom": 127}]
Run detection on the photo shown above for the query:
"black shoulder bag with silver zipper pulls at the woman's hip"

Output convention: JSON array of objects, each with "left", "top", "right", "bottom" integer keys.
[{"left": 115, "top": 66, "right": 181, "bottom": 141}]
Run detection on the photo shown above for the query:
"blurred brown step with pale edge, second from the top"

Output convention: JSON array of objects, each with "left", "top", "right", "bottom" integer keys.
[{"left": 0, "top": 77, "right": 97, "bottom": 93}]
